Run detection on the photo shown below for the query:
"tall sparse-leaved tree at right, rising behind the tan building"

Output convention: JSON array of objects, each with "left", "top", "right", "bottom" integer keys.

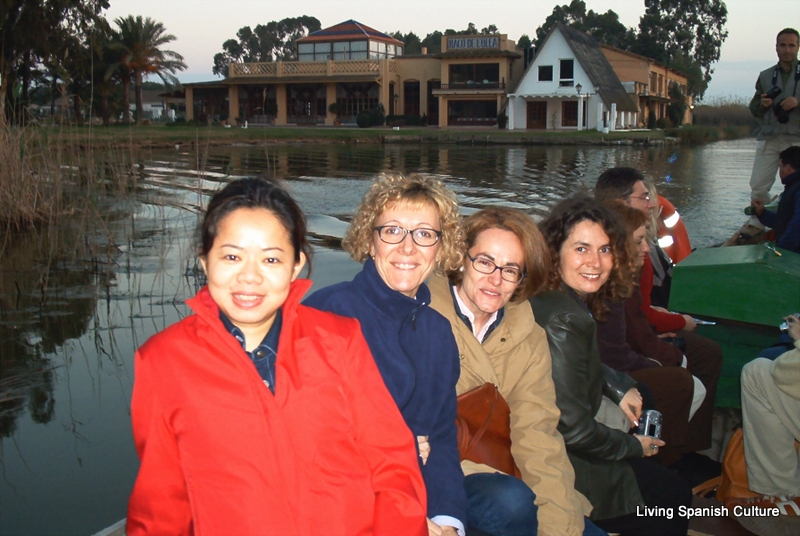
[{"left": 633, "top": 0, "right": 728, "bottom": 98}]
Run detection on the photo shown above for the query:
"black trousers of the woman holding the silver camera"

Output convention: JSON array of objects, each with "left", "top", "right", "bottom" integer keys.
[{"left": 594, "top": 458, "right": 692, "bottom": 536}]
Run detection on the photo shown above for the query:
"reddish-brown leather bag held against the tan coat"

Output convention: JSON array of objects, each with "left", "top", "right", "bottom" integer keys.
[{"left": 456, "top": 383, "right": 521, "bottom": 478}]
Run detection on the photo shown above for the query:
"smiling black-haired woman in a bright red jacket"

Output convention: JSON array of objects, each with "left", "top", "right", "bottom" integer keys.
[{"left": 127, "top": 179, "right": 427, "bottom": 536}]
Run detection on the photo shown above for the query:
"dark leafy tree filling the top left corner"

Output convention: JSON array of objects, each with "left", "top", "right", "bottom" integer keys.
[{"left": 0, "top": 0, "right": 108, "bottom": 121}]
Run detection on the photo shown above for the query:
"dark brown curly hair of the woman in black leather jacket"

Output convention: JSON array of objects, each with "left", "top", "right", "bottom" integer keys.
[{"left": 539, "top": 195, "right": 633, "bottom": 321}]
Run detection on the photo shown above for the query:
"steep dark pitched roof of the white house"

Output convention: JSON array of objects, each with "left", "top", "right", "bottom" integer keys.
[{"left": 528, "top": 23, "right": 638, "bottom": 112}]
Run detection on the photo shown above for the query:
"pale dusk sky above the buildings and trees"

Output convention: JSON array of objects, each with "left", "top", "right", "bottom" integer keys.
[{"left": 105, "top": 0, "right": 800, "bottom": 102}]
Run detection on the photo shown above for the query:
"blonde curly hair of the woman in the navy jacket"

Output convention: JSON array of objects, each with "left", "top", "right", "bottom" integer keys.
[{"left": 342, "top": 173, "right": 464, "bottom": 274}]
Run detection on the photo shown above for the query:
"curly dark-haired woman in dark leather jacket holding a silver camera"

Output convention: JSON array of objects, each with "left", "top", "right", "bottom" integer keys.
[{"left": 531, "top": 197, "right": 692, "bottom": 535}]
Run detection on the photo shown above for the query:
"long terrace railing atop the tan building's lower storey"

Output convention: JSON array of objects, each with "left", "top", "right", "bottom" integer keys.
[{"left": 228, "top": 60, "right": 396, "bottom": 78}]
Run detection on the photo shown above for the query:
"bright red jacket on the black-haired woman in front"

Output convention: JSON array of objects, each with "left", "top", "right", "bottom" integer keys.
[{"left": 127, "top": 280, "right": 428, "bottom": 536}]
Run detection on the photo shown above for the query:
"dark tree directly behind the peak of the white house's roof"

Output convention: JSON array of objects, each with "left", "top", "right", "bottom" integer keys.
[{"left": 536, "top": 0, "right": 636, "bottom": 50}]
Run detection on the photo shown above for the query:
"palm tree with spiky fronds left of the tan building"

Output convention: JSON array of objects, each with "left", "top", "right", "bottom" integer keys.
[{"left": 114, "top": 15, "right": 186, "bottom": 125}]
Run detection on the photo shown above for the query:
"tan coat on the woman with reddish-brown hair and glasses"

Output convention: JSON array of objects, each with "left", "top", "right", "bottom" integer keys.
[{"left": 428, "top": 275, "right": 592, "bottom": 536}]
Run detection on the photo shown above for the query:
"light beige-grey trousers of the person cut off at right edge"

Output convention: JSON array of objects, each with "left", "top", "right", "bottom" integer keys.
[{"left": 742, "top": 357, "right": 800, "bottom": 496}]
